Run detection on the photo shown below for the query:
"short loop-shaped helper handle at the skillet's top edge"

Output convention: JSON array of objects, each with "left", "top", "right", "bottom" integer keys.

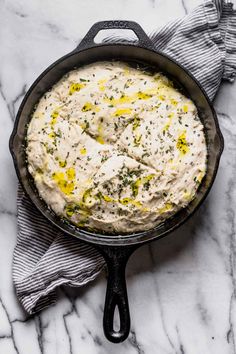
[{"left": 74, "top": 20, "right": 153, "bottom": 52}]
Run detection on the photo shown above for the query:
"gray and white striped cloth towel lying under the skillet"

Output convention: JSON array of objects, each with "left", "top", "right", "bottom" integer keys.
[{"left": 13, "top": 0, "right": 236, "bottom": 314}]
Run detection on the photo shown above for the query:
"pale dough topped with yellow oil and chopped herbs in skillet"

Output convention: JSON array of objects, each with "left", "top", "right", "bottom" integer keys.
[{"left": 27, "top": 62, "right": 207, "bottom": 233}]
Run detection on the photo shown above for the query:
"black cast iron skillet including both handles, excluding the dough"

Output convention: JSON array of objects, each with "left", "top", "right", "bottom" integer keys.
[{"left": 10, "top": 21, "right": 223, "bottom": 343}]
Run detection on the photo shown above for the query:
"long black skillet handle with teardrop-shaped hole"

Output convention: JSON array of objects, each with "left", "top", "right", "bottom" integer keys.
[{"left": 95, "top": 246, "right": 137, "bottom": 343}]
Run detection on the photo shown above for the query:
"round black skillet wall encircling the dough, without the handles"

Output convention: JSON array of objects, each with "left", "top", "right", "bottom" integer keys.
[{"left": 10, "top": 44, "right": 223, "bottom": 246}]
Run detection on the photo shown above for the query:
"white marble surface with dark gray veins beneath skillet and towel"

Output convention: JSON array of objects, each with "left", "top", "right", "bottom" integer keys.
[{"left": 0, "top": 0, "right": 236, "bottom": 354}]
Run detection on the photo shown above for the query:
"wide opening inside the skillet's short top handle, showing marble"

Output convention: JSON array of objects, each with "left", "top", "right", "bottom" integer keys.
[{"left": 94, "top": 28, "right": 138, "bottom": 44}]
